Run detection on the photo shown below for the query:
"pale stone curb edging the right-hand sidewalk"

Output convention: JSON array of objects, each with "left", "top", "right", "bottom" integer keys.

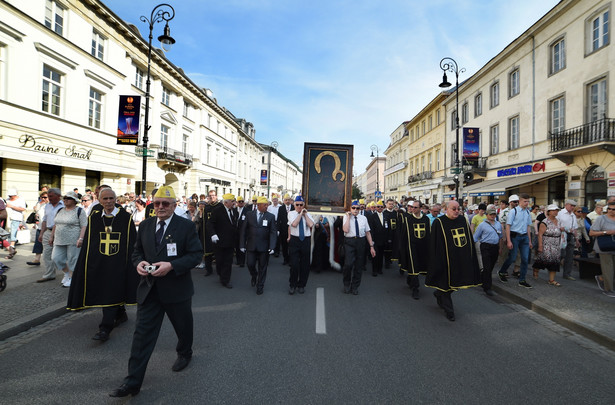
[{"left": 491, "top": 285, "right": 615, "bottom": 351}]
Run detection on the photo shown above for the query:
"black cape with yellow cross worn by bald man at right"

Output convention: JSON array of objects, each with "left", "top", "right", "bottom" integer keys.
[{"left": 425, "top": 215, "right": 481, "bottom": 291}]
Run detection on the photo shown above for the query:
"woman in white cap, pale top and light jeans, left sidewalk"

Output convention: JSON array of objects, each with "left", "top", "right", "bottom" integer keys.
[{"left": 49, "top": 191, "right": 88, "bottom": 288}]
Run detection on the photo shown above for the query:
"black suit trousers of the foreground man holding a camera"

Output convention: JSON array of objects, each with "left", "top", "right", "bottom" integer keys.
[{"left": 124, "top": 286, "right": 193, "bottom": 387}]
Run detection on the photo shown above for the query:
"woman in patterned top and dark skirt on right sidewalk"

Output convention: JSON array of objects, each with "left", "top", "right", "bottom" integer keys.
[{"left": 533, "top": 204, "right": 565, "bottom": 287}]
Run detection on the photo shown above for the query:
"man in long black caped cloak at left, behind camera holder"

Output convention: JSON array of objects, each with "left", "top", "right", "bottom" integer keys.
[{"left": 68, "top": 188, "right": 139, "bottom": 342}]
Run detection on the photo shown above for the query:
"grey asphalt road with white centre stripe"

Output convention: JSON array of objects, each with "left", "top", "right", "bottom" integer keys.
[{"left": 0, "top": 258, "right": 615, "bottom": 404}]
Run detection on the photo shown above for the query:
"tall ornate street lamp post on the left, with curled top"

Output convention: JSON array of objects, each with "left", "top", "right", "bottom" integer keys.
[{"left": 140, "top": 3, "right": 175, "bottom": 198}]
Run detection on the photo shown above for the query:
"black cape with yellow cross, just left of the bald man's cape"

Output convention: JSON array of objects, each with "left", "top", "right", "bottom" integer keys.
[{"left": 399, "top": 213, "right": 430, "bottom": 275}]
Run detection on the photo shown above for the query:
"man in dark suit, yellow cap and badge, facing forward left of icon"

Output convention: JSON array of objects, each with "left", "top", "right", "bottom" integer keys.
[{"left": 239, "top": 197, "right": 278, "bottom": 295}]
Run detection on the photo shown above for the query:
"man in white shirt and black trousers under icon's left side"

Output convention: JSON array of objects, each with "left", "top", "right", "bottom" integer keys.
[{"left": 288, "top": 195, "right": 314, "bottom": 295}]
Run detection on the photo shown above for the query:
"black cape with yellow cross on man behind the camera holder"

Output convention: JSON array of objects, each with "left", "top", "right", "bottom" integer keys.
[{"left": 67, "top": 209, "right": 140, "bottom": 310}]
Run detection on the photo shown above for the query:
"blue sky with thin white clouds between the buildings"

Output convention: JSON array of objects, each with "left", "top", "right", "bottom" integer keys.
[{"left": 103, "top": 0, "right": 558, "bottom": 174}]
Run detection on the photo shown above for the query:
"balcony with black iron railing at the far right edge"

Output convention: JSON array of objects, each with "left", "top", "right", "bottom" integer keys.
[{"left": 549, "top": 118, "right": 615, "bottom": 163}]
